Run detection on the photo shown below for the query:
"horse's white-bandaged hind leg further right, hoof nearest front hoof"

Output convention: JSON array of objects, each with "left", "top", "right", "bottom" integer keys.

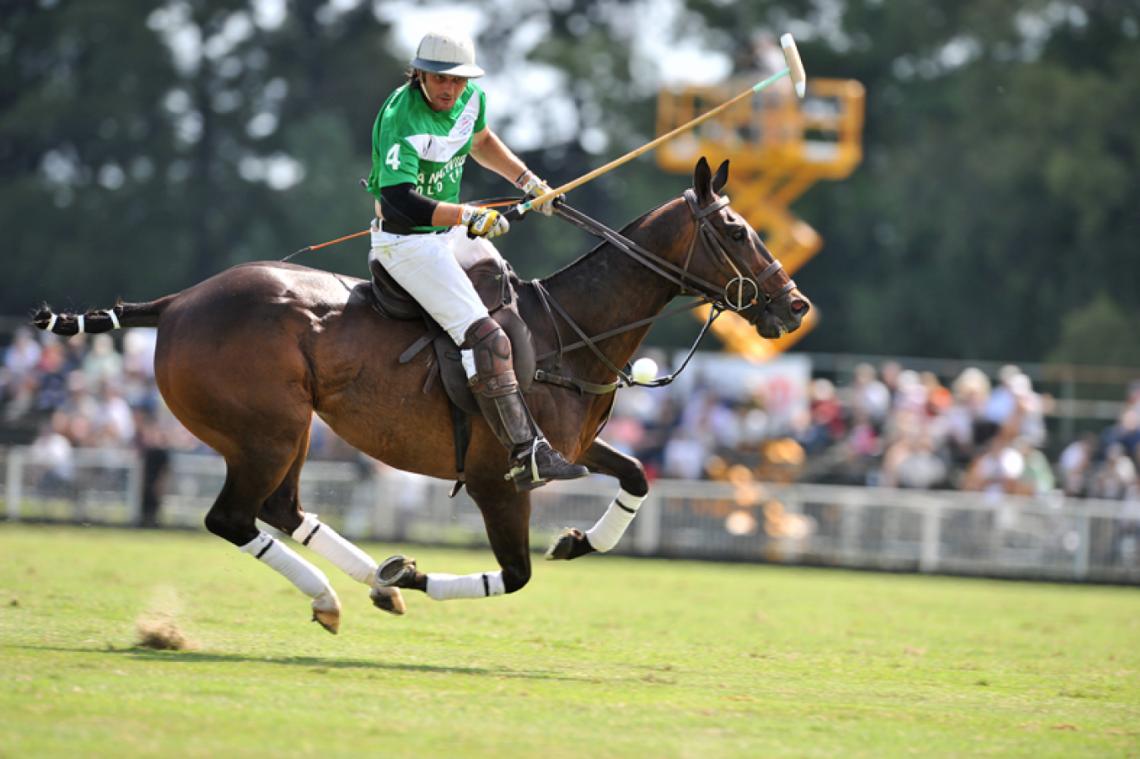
[{"left": 258, "top": 434, "right": 407, "bottom": 621}]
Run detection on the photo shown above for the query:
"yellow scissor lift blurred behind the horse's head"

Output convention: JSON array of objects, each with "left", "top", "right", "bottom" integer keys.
[{"left": 657, "top": 79, "right": 863, "bottom": 360}]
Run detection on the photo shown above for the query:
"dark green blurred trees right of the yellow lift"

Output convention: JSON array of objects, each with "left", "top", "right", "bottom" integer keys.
[{"left": 714, "top": 0, "right": 1140, "bottom": 360}]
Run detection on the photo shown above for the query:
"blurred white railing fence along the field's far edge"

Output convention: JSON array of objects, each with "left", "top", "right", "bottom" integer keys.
[{"left": 0, "top": 448, "right": 1140, "bottom": 583}]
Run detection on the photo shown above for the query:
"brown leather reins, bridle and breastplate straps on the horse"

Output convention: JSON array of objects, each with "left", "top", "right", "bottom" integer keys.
[{"left": 528, "top": 189, "right": 796, "bottom": 395}]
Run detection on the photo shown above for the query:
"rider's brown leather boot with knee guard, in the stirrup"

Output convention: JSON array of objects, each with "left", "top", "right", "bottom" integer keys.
[{"left": 464, "top": 318, "right": 589, "bottom": 491}]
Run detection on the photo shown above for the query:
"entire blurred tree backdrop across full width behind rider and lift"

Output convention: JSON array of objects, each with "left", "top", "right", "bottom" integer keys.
[{"left": 0, "top": 0, "right": 1140, "bottom": 360}]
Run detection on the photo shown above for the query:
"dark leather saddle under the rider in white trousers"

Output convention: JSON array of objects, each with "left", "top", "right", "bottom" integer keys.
[{"left": 369, "top": 259, "right": 535, "bottom": 417}]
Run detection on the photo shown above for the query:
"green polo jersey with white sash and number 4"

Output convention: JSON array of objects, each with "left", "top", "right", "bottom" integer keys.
[{"left": 368, "top": 82, "right": 487, "bottom": 230}]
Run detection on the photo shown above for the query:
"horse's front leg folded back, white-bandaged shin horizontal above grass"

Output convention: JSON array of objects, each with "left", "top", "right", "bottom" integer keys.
[{"left": 376, "top": 481, "right": 530, "bottom": 601}]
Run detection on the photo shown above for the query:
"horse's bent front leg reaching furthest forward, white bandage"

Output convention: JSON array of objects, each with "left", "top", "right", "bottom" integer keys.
[{"left": 546, "top": 439, "right": 649, "bottom": 561}]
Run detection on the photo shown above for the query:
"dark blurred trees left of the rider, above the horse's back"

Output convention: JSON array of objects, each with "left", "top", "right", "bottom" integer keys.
[{"left": 0, "top": 0, "right": 401, "bottom": 313}]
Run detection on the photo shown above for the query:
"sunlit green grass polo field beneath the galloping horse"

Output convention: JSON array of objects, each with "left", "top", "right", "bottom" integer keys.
[{"left": 0, "top": 525, "right": 1140, "bottom": 759}]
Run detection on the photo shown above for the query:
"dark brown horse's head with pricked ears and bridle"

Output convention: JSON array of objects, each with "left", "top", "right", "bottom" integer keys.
[{"left": 685, "top": 157, "right": 812, "bottom": 340}]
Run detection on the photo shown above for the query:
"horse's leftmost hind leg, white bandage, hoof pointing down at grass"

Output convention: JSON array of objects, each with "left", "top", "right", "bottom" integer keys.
[{"left": 205, "top": 449, "right": 341, "bottom": 635}]
